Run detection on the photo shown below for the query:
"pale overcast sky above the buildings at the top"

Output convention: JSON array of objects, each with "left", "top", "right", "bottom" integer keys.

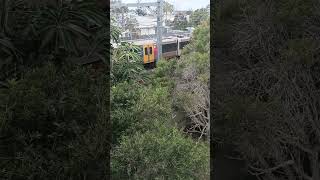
[{"left": 122, "top": 0, "right": 210, "bottom": 10}]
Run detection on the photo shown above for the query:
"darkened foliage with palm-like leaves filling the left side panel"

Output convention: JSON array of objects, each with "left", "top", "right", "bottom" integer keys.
[{"left": 0, "top": 0, "right": 110, "bottom": 180}]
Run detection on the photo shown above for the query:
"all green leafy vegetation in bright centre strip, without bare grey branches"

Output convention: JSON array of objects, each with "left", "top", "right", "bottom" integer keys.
[{"left": 111, "top": 10, "right": 209, "bottom": 179}]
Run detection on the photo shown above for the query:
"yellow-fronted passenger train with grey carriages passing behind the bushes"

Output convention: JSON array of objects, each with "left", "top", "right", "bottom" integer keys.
[{"left": 114, "top": 37, "right": 190, "bottom": 67}]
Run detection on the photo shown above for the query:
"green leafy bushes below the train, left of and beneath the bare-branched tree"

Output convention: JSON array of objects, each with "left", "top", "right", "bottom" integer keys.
[{"left": 111, "top": 54, "right": 209, "bottom": 179}]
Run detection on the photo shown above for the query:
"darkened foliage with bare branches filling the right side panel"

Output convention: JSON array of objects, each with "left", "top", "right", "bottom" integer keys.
[{"left": 213, "top": 0, "right": 320, "bottom": 180}]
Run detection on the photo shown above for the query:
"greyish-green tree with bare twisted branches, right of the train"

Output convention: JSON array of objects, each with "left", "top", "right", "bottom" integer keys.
[{"left": 175, "top": 19, "right": 210, "bottom": 139}]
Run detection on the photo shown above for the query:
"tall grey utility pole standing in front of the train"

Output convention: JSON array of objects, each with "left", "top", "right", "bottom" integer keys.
[{"left": 156, "top": 0, "right": 163, "bottom": 63}]
